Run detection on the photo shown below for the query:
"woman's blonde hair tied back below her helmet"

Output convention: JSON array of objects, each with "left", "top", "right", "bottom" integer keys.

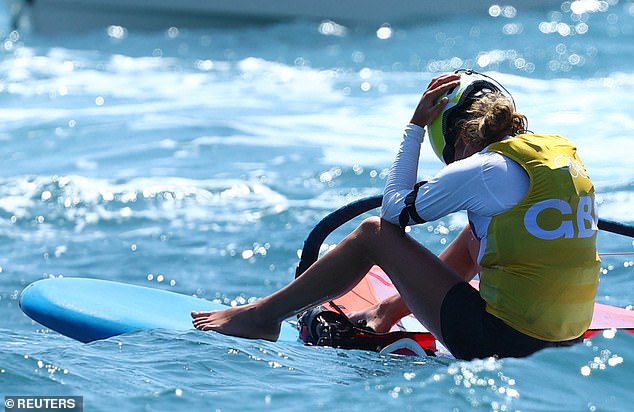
[{"left": 456, "top": 92, "right": 528, "bottom": 148}]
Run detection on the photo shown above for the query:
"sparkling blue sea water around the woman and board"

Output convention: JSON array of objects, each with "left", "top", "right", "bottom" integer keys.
[{"left": 0, "top": 0, "right": 634, "bottom": 411}]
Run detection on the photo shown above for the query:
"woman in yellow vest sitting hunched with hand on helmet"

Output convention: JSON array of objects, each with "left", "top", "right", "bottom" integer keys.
[{"left": 192, "top": 71, "right": 600, "bottom": 359}]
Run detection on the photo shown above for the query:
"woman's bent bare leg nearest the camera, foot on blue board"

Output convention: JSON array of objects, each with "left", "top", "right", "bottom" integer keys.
[{"left": 192, "top": 218, "right": 464, "bottom": 340}]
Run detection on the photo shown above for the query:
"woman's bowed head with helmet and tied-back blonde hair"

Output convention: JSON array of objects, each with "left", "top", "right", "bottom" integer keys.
[{"left": 428, "top": 70, "right": 527, "bottom": 164}]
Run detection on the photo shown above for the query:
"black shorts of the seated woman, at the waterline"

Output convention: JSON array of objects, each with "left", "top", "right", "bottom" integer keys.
[{"left": 440, "top": 282, "right": 583, "bottom": 360}]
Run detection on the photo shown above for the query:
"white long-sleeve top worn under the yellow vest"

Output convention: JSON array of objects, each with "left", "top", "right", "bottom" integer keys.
[{"left": 381, "top": 124, "right": 529, "bottom": 239}]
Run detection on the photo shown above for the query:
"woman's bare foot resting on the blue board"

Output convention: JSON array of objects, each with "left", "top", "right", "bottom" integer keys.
[{"left": 191, "top": 304, "right": 281, "bottom": 342}]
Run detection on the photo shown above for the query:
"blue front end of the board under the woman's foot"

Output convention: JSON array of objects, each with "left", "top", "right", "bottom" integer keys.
[{"left": 19, "top": 278, "right": 297, "bottom": 342}]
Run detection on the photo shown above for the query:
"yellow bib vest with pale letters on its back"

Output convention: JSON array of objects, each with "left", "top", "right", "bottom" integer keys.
[{"left": 480, "top": 134, "right": 601, "bottom": 342}]
